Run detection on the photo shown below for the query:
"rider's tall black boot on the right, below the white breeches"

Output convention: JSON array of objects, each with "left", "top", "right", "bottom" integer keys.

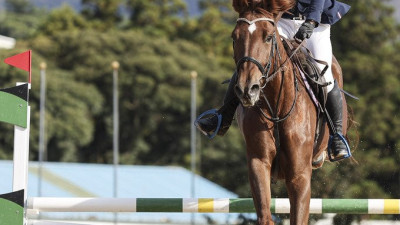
[{"left": 326, "top": 81, "right": 348, "bottom": 159}]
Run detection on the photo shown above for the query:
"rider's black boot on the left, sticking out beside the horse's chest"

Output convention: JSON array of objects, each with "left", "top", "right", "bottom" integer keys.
[{"left": 195, "top": 73, "right": 239, "bottom": 136}]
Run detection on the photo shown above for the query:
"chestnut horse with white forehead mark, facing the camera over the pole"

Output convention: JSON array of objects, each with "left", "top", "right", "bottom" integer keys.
[{"left": 232, "top": 0, "right": 347, "bottom": 225}]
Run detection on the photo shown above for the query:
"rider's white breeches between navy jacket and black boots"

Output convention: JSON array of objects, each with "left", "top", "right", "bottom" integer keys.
[{"left": 278, "top": 19, "right": 334, "bottom": 92}]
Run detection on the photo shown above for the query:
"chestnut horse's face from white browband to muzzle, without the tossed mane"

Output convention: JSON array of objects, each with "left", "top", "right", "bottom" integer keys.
[{"left": 232, "top": 13, "right": 276, "bottom": 107}]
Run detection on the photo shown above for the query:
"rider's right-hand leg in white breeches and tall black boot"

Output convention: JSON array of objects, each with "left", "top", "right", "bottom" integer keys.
[{"left": 306, "top": 24, "right": 348, "bottom": 156}]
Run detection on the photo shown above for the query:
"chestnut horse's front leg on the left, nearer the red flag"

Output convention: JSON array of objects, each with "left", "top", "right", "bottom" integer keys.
[{"left": 247, "top": 150, "right": 274, "bottom": 225}]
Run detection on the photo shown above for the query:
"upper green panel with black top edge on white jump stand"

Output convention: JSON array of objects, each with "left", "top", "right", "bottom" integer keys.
[{"left": 0, "top": 84, "right": 28, "bottom": 128}]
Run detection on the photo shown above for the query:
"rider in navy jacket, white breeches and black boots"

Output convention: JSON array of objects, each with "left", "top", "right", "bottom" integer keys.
[{"left": 195, "top": 0, "right": 350, "bottom": 159}]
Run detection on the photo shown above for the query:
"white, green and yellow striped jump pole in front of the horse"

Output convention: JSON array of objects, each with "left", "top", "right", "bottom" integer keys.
[{"left": 27, "top": 197, "right": 400, "bottom": 214}]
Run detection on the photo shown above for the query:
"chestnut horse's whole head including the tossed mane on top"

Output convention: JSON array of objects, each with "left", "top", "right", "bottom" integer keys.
[{"left": 232, "top": 0, "right": 292, "bottom": 107}]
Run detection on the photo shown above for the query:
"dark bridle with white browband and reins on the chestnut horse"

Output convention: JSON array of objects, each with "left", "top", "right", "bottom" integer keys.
[{"left": 236, "top": 17, "right": 302, "bottom": 123}]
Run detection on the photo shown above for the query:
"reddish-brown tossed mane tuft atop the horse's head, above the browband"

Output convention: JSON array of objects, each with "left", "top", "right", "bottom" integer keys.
[{"left": 232, "top": 0, "right": 296, "bottom": 15}]
